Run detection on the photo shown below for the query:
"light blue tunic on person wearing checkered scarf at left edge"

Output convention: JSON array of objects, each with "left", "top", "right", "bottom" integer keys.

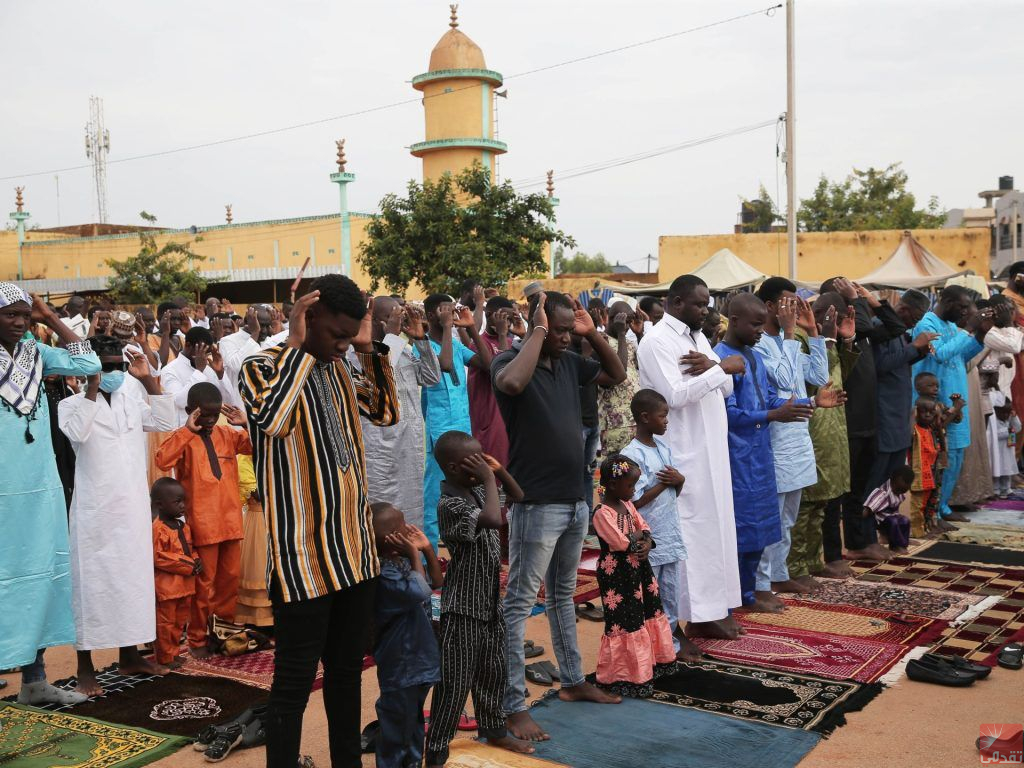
[{"left": 0, "top": 344, "right": 100, "bottom": 669}]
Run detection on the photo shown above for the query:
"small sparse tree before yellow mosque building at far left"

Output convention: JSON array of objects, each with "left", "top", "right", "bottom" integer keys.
[{"left": 106, "top": 211, "right": 210, "bottom": 304}]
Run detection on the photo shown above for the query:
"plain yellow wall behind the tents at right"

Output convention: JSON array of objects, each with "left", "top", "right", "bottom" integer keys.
[{"left": 658, "top": 228, "right": 990, "bottom": 282}]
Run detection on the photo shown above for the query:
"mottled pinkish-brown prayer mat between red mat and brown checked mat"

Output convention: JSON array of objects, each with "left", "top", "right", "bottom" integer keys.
[{"left": 785, "top": 577, "right": 985, "bottom": 622}]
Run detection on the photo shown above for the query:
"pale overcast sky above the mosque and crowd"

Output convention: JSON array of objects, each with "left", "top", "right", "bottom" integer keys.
[{"left": 0, "top": 0, "right": 1024, "bottom": 268}]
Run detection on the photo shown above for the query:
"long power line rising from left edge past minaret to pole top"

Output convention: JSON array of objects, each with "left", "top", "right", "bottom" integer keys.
[{"left": 0, "top": 4, "right": 782, "bottom": 181}]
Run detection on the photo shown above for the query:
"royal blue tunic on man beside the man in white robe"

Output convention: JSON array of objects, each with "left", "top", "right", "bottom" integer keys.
[{"left": 715, "top": 341, "right": 807, "bottom": 552}]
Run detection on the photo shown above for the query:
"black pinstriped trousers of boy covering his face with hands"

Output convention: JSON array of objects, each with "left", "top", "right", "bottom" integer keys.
[{"left": 427, "top": 613, "right": 508, "bottom": 765}]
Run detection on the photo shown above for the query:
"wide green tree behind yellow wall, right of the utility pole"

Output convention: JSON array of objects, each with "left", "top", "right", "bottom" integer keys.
[{"left": 797, "top": 163, "right": 946, "bottom": 232}]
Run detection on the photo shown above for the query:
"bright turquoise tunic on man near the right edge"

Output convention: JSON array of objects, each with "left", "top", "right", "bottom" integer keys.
[{"left": 910, "top": 312, "right": 985, "bottom": 451}]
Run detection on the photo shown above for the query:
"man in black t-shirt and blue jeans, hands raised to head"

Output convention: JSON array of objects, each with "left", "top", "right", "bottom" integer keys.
[{"left": 490, "top": 293, "right": 626, "bottom": 741}]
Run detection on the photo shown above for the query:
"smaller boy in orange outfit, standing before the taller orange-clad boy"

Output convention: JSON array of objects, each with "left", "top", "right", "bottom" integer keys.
[{"left": 150, "top": 477, "right": 203, "bottom": 667}]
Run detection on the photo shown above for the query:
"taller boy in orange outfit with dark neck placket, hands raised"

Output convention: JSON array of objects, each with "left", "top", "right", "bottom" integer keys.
[{"left": 157, "top": 382, "right": 253, "bottom": 658}]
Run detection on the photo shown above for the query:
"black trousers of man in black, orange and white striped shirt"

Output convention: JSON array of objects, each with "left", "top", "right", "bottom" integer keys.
[{"left": 264, "top": 579, "right": 377, "bottom": 768}]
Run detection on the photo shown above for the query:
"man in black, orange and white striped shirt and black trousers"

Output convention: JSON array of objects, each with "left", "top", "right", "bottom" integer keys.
[{"left": 239, "top": 274, "right": 398, "bottom": 768}]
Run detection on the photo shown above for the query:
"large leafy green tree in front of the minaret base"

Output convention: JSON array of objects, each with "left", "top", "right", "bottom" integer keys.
[{"left": 360, "top": 163, "right": 575, "bottom": 295}]
